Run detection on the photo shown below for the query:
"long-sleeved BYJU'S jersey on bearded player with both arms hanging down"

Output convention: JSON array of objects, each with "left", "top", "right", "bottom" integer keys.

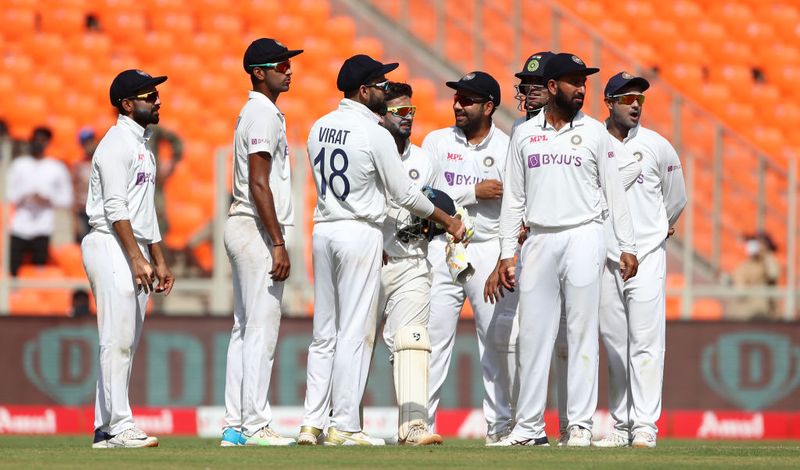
[{"left": 500, "top": 111, "right": 636, "bottom": 259}]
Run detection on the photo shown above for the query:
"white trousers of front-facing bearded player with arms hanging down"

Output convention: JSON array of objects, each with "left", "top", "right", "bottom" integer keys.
[{"left": 514, "top": 222, "right": 606, "bottom": 438}]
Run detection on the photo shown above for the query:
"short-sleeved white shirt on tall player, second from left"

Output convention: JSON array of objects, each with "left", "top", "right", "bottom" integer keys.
[{"left": 228, "top": 91, "right": 294, "bottom": 226}]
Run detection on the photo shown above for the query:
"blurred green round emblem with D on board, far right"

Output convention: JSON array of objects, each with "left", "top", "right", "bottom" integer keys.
[{"left": 701, "top": 331, "right": 800, "bottom": 410}]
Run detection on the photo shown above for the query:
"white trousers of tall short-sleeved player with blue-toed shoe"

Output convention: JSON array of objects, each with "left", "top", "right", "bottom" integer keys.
[{"left": 225, "top": 215, "right": 284, "bottom": 436}]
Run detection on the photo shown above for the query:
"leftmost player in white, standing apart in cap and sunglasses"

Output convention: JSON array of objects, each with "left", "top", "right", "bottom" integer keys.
[{"left": 81, "top": 70, "right": 175, "bottom": 448}]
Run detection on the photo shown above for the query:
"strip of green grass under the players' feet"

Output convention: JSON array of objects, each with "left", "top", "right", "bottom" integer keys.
[{"left": 0, "top": 436, "right": 800, "bottom": 470}]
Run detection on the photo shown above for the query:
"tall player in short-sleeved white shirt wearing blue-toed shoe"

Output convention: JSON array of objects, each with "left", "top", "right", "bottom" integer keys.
[{"left": 220, "top": 38, "right": 303, "bottom": 447}]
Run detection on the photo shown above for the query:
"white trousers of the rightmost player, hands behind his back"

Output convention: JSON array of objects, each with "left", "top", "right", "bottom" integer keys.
[{"left": 600, "top": 243, "right": 667, "bottom": 438}]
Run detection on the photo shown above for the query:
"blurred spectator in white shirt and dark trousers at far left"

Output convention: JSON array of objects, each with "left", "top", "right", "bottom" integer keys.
[{"left": 6, "top": 127, "right": 73, "bottom": 276}]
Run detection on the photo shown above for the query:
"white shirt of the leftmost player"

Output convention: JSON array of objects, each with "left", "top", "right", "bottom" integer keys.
[{"left": 86, "top": 115, "right": 161, "bottom": 244}]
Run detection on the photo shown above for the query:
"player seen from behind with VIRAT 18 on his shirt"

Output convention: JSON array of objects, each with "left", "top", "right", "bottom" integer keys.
[{"left": 298, "top": 54, "right": 464, "bottom": 445}]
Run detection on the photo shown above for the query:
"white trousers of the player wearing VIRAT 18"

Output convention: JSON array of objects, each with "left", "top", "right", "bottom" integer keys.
[{"left": 303, "top": 220, "right": 383, "bottom": 432}]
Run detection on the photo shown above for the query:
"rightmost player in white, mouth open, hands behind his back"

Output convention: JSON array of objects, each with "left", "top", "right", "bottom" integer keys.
[{"left": 594, "top": 72, "right": 686, "bottom": 447}]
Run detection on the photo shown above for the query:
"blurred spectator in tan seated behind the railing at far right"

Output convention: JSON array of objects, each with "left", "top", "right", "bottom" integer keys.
[{"left": 726, "top": 232, "right": 781, "bottom": 320}]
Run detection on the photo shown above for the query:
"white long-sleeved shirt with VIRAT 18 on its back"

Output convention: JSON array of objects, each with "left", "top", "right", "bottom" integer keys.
[{"left": 307, "top": 98, "right": 434, "bottom": 225}]
